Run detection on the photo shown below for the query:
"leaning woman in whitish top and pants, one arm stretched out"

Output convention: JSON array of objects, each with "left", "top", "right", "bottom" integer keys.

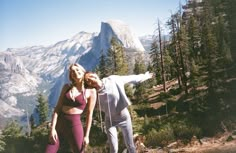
[{"left": 84, "top": 72, "right": 154, "bottom": 153}]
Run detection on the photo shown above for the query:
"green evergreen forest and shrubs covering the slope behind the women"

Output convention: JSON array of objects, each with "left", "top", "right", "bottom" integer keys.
[{"left": 0, "top": 0, "right": 236, "bottom": 153}]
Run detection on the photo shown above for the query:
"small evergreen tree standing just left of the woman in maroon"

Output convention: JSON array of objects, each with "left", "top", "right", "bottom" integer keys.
[{"left": 36, "top": 93, "right": 48, "bottom": 124}]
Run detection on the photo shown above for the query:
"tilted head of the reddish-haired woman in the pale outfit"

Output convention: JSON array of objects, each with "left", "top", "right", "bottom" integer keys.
[{"left": 84, "top": 73, "right": 100, "bottom": 88}]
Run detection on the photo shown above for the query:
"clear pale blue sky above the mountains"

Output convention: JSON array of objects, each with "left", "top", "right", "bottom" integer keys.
[{"left": 0, "top": 0, "right": 185, "bottom": 51}]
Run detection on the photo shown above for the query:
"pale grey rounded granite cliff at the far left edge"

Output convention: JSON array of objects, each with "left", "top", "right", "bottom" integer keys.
[{"left": 0, "top": 52, "right": 39, "bottom": 118}]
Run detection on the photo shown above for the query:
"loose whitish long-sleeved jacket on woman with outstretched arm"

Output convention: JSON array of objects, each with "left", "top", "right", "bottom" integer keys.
[{"left": 98, "top": 72, "right": 151, "bottom": 118}]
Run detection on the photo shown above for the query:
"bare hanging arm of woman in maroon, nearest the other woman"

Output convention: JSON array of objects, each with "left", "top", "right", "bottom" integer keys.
[{"left": 84, "top": 89, "right": 97, "bottom": 146}]
